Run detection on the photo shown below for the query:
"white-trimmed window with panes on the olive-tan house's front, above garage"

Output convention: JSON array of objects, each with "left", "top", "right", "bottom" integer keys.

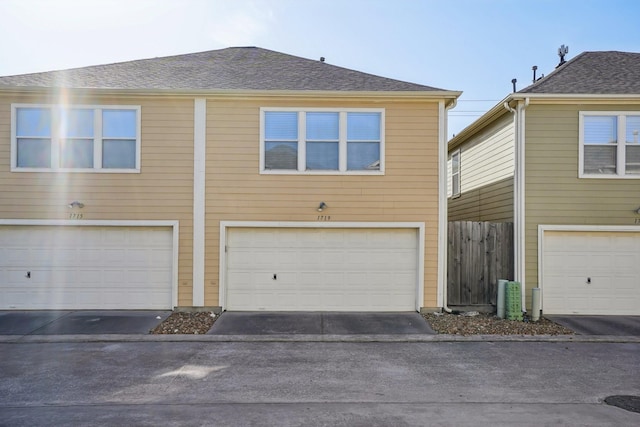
[{"left": 579, "top": 111, "right": 640, "bottom": 178}]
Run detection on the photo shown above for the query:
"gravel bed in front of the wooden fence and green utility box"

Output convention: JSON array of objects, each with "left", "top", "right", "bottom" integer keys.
[{"left": 422, "top": 313, "right": 575, "bottom": 335}]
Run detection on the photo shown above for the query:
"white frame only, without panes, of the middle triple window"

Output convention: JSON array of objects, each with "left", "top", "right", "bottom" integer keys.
[{"left": 260, "top": 107, "right": 385, "bottom": 175}]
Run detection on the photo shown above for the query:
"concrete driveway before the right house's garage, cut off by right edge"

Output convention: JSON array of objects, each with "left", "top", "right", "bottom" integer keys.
[{"left": 545, "top": 315, "right": 640, "bottom": 337}]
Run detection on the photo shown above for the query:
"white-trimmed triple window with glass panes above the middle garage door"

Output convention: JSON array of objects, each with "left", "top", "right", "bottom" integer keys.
[{"left": 260, "top": 108, "right": 384, "bottom": 174}]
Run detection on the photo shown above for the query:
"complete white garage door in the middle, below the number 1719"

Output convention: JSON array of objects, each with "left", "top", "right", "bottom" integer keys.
[{"left": 226, "top": 228, "right": 418, "bottom": 311}]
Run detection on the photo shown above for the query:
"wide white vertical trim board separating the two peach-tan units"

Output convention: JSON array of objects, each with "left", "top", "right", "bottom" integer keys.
[{"left": 193, "top": 98, "right": 207, "bottom": 307}]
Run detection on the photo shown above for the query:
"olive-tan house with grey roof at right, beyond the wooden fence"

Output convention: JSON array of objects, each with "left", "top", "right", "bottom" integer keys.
[{"left": 448, "top": 52, "right": 640, "bottom": 315}]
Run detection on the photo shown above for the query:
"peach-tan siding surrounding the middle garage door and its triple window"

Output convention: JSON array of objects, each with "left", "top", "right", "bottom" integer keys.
[{"left": 205, "top": 100, "right": 438, "bottom": 307}]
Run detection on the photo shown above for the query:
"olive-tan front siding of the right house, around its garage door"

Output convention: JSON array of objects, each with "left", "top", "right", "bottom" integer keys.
[{"left": 525, "top": 104, "right": 640, "bottom": 297}]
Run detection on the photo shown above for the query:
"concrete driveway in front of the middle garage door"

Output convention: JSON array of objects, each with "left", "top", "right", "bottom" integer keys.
[{"left": 207, "top": 311, "right": 435, "bottom": 335}]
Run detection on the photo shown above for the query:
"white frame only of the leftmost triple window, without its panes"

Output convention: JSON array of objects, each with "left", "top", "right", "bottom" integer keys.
[{"left": 11, "top": 104, "right": 142, "bottom": 173}]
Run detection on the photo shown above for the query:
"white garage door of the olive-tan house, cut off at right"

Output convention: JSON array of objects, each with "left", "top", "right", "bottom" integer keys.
[{"left": 542, "top": 231, "right": 640, "bottom": 315}]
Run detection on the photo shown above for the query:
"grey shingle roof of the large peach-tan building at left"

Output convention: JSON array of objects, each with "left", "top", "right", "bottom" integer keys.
[{"left": 0, "top": 47, "right": 442, "bottom": 92}]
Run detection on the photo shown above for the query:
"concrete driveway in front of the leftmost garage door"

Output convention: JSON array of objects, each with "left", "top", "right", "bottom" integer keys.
[{"left": 0, "top": 310, "right": 171, "bottom": 335}]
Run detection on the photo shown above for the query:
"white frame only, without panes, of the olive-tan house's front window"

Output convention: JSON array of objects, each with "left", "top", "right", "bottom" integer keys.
[{"left": 578, "top": 111, "right": 640, "bottom": 179}]
